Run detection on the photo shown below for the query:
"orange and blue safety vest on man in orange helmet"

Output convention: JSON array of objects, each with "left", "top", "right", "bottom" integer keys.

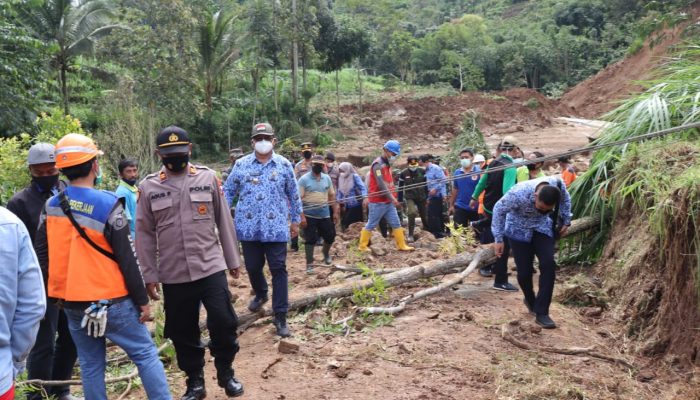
[{"left": 46, "top": 186, "right": 129, "bottom": 301}]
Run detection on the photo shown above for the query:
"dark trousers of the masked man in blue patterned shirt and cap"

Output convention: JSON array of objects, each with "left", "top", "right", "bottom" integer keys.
[{"left": 241, "top": 241, "right": 289, "bottom": 313}]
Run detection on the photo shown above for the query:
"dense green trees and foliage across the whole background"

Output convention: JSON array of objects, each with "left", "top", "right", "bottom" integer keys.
[{"left": 0, "top": 0, "right": 688, "bottom": 162}]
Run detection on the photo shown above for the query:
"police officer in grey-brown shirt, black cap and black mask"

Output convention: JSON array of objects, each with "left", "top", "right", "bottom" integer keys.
[{"left": 136, "top": 126, "right": 243, "bottom": 400}]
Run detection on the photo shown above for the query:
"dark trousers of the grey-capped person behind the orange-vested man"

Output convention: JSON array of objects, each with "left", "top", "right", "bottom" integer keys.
[{"left": 27, "top": 303, "right": 78, "bottom": 399}]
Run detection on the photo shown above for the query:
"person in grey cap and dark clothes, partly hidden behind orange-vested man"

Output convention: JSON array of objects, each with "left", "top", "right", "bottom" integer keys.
[{"left": 7, "top": 143, "right": 78, "bottom": 400}]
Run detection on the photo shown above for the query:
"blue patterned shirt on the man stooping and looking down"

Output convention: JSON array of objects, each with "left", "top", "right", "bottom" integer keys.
[{"left": 491, "top": 176, "right": 571, "bottom": 243}]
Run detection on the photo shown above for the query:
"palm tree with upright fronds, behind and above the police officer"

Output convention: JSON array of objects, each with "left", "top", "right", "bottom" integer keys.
[{"left": 198, "top": 11, "right": 239, "bottom": 111}]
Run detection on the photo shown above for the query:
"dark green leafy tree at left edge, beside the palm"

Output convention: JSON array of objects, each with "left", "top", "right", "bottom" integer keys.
[{"left": 0, "top": 3, "right": 46, "bottom": 137}]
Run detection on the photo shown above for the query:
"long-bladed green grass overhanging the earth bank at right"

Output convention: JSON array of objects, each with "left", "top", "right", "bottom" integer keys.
[{"left": 571, "top": 44, "right": 700, "bottom": 262}]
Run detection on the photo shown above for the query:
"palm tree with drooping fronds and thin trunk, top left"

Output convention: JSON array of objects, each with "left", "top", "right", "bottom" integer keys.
[{"left": 19, "top": 0, "right": 119, "bottom": 114}]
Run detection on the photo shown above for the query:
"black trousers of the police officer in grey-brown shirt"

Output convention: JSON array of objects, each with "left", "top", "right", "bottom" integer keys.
[{"left": 163, "top": 270, "right": 239, "bottom": 378}]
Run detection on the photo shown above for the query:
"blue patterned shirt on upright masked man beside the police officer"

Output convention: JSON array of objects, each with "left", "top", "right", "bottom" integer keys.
[{"left": 224, "top": 153, "right": 301, "bottom": 242}]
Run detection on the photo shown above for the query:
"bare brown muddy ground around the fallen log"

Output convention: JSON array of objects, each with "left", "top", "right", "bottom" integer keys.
[{"left": 146, "top": 228, "right": 698, "bottom": 399}]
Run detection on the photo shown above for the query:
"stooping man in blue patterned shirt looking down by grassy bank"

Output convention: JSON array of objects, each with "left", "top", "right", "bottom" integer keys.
[{"left": 491, "top": 177, "right": 571, "bottom": 329}]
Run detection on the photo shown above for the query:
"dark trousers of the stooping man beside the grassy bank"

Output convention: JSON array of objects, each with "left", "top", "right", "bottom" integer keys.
[{"left": 509, "top": 232, "right": 555, "bottom": 315}]
